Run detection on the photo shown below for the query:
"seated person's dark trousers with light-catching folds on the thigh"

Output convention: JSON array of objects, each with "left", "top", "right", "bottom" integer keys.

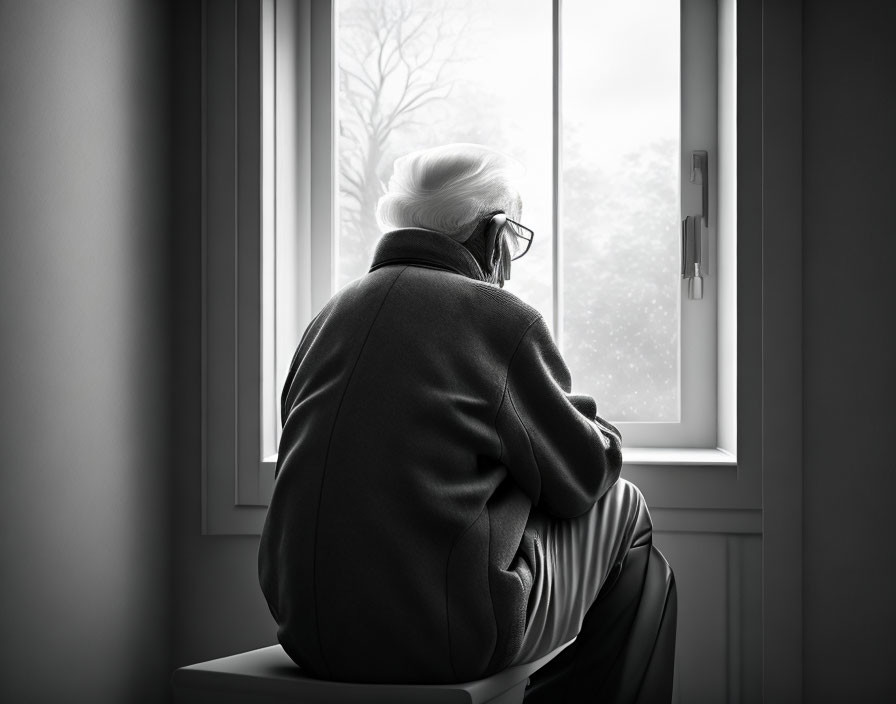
[{"left": 514, "top": 480, "right": 677, "bottom": 704}]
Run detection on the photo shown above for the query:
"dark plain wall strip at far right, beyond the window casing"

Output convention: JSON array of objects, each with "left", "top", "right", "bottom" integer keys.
[{"left": 803, "top": 0, "right": 896, "bottom": 702}]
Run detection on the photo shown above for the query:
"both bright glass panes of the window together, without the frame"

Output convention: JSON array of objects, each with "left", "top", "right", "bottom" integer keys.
[{"left": 335, "top": 0, "right": 681, "bottom": 422}]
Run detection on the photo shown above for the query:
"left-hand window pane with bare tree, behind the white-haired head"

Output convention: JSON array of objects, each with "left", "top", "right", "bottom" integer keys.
[{"left": 336, "top": 0, "right": 553, "bottom": 324}]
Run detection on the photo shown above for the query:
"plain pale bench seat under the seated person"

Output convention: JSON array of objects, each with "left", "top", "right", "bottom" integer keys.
[{"left": 171, "top": 641, "right": 572, "bottom": 704}]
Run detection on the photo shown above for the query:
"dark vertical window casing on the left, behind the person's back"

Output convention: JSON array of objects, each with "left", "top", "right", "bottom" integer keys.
[{"left": 201, "top": 0, "right": 273, "bottom": 535}]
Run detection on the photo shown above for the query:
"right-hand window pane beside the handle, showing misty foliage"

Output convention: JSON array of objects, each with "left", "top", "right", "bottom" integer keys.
[{"left": 560, "top": 0, "right": 681, "bottom": 422}]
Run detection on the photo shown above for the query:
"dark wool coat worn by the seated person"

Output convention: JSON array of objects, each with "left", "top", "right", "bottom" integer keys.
[{"left": 259, "top": 229, "right": 622, "bottom": 682}]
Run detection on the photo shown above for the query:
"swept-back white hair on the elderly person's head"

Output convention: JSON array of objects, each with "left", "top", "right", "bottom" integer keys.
[{"left": 376, "top": 143, "right": 522, "bottom": 240}]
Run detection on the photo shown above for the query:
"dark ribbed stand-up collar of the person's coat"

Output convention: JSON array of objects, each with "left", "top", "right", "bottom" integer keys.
[{"left": 370, "top": 227, "right": 485, "bottom": 281}]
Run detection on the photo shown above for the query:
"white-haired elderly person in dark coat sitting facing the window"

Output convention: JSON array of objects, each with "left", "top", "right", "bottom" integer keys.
[{"left": 259, "top": 144, "right": 675, "bottom": 702}]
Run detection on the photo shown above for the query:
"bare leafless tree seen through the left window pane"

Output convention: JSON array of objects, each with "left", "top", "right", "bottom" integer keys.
[{"left": 339, "top": 0, "right": 465, "bottom": 280}]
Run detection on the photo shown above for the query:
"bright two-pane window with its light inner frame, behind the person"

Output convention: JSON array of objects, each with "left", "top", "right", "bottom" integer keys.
[{"left": 264, "top": 0, "right": 734, "bottom": 454}]
